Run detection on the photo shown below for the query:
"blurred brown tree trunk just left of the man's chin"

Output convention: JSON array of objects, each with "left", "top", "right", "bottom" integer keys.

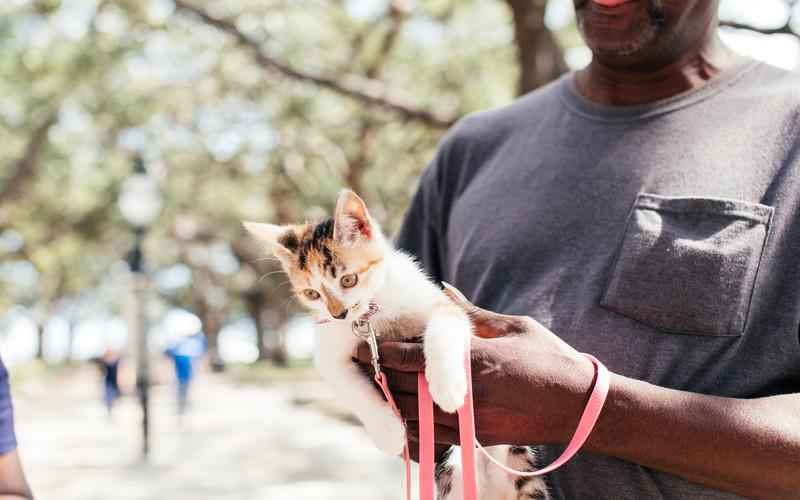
[{"left": 506, "top": 0, "right": 568, "bottom": 95}]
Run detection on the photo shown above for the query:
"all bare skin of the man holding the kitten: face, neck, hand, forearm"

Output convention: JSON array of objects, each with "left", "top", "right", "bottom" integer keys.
[{"left": 355, "top": 0, "right": 800, "bottom": 500}]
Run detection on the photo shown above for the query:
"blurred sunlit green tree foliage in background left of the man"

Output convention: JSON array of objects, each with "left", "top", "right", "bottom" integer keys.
[{"left": 0, "top": 0, "right": 536, "bottom": 346}]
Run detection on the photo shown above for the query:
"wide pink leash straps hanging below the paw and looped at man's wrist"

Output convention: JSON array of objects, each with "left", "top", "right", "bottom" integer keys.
[{"left": 418, "top": 351, "right": 610, "bottom": 500}]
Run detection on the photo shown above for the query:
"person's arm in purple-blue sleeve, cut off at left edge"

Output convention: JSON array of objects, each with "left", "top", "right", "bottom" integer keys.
[{"left": 0, "top": 360, "right": 33, "bottom": 500}]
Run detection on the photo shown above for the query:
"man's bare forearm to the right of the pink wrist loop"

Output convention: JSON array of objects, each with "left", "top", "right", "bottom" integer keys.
[{"left": 587, "top": 375, "right": 800, "bottom": 499}]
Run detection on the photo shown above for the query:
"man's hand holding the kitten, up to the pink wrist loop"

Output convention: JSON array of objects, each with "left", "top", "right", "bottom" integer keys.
[{"left": 356, "top": 287, "right": 594, "bottom": 445}]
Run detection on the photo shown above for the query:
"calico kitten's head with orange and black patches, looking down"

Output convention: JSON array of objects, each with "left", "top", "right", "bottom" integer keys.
[{"left": 244, "top": 191, "right": 389, "bottom": 321}]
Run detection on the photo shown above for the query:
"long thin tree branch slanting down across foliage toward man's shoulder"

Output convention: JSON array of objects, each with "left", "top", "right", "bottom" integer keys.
[{"left": 175, "top": 0, "right": 455, "bottom": 128}]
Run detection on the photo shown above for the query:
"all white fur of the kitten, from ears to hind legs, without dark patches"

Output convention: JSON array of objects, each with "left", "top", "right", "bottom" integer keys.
[{"left": 245, "top": 191, "right": 546, "bottom": 500}]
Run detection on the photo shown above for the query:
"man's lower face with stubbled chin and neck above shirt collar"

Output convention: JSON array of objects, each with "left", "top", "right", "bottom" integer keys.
[{"left": 575, "top": 0, "right": 738, "bottom": 106}]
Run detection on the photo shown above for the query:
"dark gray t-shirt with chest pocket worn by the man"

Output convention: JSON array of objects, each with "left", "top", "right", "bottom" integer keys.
[{"left": 398, "top": 59, "right": 800, "bottom": 500}]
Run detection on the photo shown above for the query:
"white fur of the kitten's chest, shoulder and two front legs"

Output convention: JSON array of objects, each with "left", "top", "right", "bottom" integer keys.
[{"left": 316, "top": 249, "right": 472, "bottom": 455}]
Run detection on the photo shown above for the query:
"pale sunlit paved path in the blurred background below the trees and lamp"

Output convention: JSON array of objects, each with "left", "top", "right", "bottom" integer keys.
[{"left": 15, "top": 372, "right": 412, "bottom": 500}]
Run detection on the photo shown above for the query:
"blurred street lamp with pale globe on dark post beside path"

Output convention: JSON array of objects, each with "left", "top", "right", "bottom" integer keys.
[{"left": 119, "top": 156, "right": 161, "bottom": 459}]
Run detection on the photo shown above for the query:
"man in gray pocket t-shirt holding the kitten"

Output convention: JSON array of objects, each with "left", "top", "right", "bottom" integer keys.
[{"left": 357, "top": 0, "right": 800, "bottom": 500}]
